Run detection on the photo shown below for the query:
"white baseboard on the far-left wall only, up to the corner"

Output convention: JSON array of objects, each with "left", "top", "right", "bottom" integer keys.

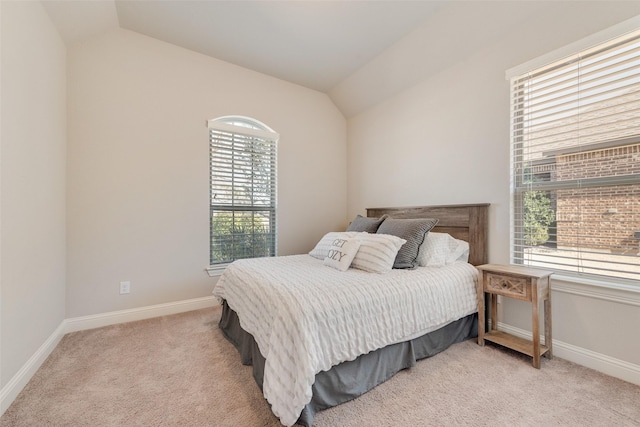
[{"left": 0, "top": 320, "right": 65, "bottom": 416}]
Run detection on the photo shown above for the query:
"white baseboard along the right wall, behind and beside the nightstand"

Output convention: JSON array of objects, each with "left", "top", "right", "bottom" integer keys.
[{"left": 498, "top": 322, "right": 640, "bottom": 385}]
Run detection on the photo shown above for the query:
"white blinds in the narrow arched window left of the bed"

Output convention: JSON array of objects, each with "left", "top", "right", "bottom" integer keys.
[{"left": 208, "top": 117, "right": 278, "bottom": 265}]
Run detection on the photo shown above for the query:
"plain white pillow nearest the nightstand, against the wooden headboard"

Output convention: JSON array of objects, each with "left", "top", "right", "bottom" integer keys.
[{"left": 418, "top": 232, "right": 469, "bottom": 267}]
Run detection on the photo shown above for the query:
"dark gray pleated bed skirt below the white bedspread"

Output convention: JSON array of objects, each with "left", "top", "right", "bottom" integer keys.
[{"left": 219, "top": 301, "right": 478, "bottom": 427}]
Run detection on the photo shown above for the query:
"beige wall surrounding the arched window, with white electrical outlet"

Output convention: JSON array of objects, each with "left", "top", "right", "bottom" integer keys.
[{"left": 67, "top": 29, "right": 346, "bottom": 318}]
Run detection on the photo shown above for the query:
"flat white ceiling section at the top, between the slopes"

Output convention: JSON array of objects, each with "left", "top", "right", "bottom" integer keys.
[{"left": 115, "top": 0, "right": 442, "bottom": 92}]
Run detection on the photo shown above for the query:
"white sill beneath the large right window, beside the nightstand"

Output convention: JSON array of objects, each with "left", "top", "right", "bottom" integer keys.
[{"left": 551, "top": 273, "right": 640, "bottom": 307}]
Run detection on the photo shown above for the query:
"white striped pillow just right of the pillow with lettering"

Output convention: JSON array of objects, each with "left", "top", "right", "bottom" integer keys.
[{"left": 351, "top": 232, "right": 406, "bottom": 273}]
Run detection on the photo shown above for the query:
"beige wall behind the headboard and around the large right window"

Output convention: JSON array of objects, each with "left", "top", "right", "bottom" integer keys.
[{"left": 347, "top": 2, "right": 640, "bottom": 365}]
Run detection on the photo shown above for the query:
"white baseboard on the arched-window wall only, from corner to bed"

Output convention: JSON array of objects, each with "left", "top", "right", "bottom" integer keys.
[{"left": 64, "top": 296, "right": 218, "bottom": 333}]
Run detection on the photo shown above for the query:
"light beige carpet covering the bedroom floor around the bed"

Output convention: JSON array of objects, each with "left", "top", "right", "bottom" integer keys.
[{"left": 0, "top": 307, "right": 640, "bottom": 427}]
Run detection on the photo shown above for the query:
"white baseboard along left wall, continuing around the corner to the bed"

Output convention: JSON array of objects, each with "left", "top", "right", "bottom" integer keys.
[{"left": 0, "top": 296, "right": 218, "bottom": 416}]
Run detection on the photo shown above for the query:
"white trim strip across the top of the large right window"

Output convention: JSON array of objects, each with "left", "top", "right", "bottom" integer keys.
[{"left": 505, "top": 15, "right": 640, "bottom": 80}]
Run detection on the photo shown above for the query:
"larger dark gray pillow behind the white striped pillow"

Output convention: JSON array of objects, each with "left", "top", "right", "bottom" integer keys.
[{"left": 377, "top": 218, "right": 438, "bottom": 268}]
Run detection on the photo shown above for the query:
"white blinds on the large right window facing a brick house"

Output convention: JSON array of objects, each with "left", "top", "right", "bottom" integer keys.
[{"left": 511, "top": 27, "right": 640, "bottom": 285}]
